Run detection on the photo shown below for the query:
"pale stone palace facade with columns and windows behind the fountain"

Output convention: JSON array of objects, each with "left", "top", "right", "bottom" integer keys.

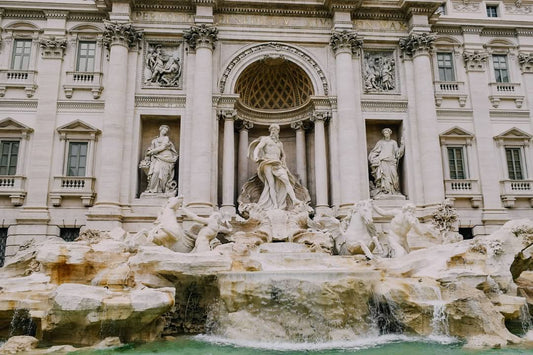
[{"left": 0, "top": 0, "right": 533, "bottom": 259}]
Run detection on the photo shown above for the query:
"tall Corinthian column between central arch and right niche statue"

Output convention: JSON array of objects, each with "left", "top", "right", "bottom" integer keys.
[{"left": 330, "top": 31, "right": 368, "bottom": 213}]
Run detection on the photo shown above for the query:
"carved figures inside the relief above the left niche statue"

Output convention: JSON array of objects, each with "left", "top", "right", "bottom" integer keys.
[{"left": 145, "top": 45, "right": 181, "bottom": 87}]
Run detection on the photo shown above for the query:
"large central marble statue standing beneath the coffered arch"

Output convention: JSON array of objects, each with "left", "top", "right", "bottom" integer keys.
[{"left": 239, "top": 124, "right": 310, "bottom": 214}]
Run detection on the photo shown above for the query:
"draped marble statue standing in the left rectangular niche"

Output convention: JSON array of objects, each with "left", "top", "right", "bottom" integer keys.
[{"left": 139, "top": 125, "right": 178, "bottom": 196}]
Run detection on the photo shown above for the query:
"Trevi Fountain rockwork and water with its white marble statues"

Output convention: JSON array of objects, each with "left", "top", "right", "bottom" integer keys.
[{"left": 0, "top": 125, "right": 533, "bottom": 354}]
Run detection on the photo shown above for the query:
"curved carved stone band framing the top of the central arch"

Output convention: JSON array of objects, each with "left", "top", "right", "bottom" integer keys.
[{"left": 219, "top": 42, "right": 329, "bottom": 95}]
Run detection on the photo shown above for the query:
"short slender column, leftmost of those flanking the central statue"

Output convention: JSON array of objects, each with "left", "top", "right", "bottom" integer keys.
[{"left": 220, "top": 110, "right": 237, "bottom": 215}]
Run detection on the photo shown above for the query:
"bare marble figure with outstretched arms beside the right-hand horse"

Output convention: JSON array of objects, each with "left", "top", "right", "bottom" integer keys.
[{"left": 374, "top": 203, "right": 439, "bottom": 258}]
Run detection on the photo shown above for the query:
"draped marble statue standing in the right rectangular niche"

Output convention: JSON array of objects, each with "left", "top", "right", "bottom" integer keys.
[{"left": 368, "top": 128, "right": 405, "bottom": 200}]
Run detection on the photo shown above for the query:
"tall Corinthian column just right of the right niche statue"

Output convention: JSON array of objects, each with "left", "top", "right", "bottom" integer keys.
[{"left": 400, "top": 33, "right": 444, "bottom": 205}]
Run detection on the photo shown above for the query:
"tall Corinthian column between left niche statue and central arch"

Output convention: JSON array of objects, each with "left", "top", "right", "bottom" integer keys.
[{"left": 183, "top": 25, "right": 218, "bottom": 213}]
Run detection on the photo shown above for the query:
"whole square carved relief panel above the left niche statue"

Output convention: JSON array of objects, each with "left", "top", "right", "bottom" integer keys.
[{"left": 143, "top": 43, "right": 183, "bottom": 88}]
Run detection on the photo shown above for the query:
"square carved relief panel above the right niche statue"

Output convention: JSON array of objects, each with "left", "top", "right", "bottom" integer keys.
[{"left": 363, "top": 51, "right": 397, "bottom": 93}]
